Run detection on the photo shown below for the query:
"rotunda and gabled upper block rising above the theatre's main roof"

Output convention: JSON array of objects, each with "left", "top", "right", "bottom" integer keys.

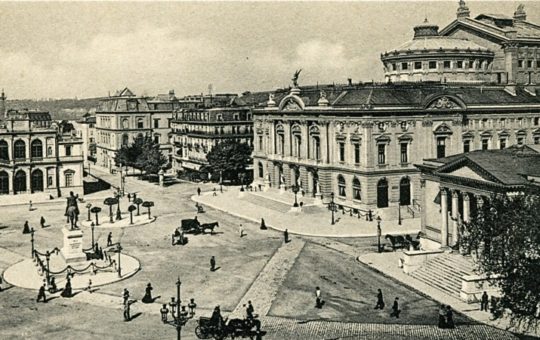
[{"left": 381, "top": 0, "right": 540, "bottom": 86}]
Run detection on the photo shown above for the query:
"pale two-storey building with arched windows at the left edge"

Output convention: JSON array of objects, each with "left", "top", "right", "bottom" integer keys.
[{"left": 0, "top": 105, "right": 84, "bottom": 197}]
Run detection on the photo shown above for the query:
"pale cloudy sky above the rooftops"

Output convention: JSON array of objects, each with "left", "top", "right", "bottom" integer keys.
[{"left": 0, "top": 0, "right": 540, "bottom": 99}]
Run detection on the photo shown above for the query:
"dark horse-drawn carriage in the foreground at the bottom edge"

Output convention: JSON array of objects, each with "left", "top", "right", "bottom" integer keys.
[{"left": 195, "top": 316, "right": 261, "bottom": 340}]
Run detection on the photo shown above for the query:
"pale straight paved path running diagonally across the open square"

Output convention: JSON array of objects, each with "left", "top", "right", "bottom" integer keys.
[{"left": 229, "top": 239, "right": 306, "bottom": 318}]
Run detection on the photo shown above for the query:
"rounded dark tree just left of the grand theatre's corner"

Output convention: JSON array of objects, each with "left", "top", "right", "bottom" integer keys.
[{"left": 206, "top": 140, "right": 252, "bottom": 180}]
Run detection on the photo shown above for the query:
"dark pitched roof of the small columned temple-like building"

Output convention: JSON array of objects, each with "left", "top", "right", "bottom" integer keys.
[{"left": 433, "top": 146, "right": 540, "bottom": 186}]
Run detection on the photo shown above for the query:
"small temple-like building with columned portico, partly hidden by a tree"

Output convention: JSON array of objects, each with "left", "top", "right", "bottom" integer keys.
[{"left": 418, "top": 145, "right": 540, "bottom": 249}]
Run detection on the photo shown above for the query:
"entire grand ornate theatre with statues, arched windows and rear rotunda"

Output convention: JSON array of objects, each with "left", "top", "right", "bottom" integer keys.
[{"left": 253, "top": 1, "right": 540, "bottom": 219}]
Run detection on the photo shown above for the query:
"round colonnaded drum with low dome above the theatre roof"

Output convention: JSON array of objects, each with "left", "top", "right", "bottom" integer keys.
[{"left": 381, "top": 19, "right": 495, "bottom": 82}]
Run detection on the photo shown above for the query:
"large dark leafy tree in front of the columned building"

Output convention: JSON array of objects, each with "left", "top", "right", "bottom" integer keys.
[{"left": 460, "top": 191, "right": 540, "bottom": 329}]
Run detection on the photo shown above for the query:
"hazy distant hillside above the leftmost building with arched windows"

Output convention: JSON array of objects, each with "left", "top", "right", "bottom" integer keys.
[{"left": 6, "top": 98, "right": 100, "bottom": 120}]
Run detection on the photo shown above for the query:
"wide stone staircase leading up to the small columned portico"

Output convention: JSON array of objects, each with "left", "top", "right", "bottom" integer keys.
[{"left": 411, "top": 253, "right": 474, "bottom": 298}]
